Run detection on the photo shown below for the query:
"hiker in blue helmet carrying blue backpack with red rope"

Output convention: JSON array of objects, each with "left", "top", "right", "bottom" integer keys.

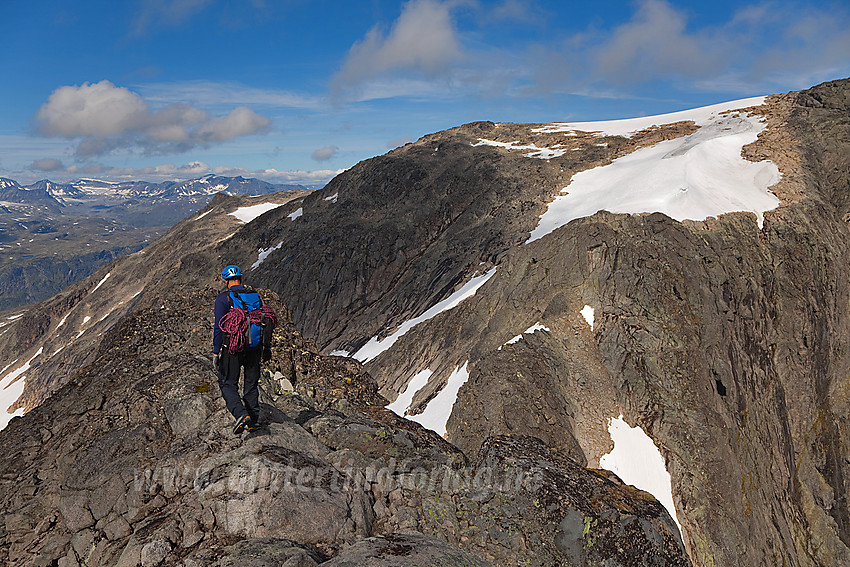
[{"left": 213, "top": 265, "right": 277, "bottom": 435}]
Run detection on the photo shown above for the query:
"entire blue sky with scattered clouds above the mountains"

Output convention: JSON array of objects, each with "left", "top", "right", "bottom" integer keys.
[{"left": 0, "top": 0, "right": 850, "bottom": 185}]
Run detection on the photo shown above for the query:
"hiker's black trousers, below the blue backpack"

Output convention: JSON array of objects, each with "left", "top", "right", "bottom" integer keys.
[{"left": 218, "top": 347, "right": 261, "bottom": 423}]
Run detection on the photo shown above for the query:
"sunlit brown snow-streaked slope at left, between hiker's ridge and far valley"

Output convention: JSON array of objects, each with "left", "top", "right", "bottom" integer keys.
[{"left": 0, "top": 191, "right": 308, "bottom": 426}]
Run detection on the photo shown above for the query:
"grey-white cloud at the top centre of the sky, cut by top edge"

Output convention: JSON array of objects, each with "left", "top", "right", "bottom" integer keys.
[{"left": 332, "top": 0, "right": 463, "bottom": 90}]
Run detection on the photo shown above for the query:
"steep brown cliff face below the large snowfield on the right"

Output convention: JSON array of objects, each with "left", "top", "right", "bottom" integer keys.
[{"left": 342, "top": 81, "right": 850, "bottom": 565}]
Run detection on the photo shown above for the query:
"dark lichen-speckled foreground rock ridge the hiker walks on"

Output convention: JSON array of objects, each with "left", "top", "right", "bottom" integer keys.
[{"left": 0, "top": 288, "right": 689, "bottom": 567}]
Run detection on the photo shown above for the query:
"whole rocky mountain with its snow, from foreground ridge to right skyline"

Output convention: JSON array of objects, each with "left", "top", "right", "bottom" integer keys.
[{"left": 0, "top": 80, "right": 850, "bottom": 567}]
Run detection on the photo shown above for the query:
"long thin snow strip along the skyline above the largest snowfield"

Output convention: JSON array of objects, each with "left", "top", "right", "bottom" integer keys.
[{"left": 532, "top": 96, "right": 766, "bottom": 138}]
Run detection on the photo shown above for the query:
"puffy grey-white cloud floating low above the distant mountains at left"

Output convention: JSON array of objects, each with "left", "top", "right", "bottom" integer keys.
[{"left": 36, "top": 81, "right": 271, "bottom": 159}]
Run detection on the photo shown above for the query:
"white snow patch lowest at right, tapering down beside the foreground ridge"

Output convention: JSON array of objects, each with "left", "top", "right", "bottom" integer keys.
[{"left": 599, "top": 415, "right": 682, "bottom": 533}]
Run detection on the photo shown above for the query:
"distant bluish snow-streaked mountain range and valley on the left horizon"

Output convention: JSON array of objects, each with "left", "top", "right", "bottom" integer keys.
[{"left": 0, "top": 175, "right": 306, "bottom": 309}]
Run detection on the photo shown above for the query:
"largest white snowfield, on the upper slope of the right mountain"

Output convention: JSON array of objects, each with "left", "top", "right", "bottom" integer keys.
[{"left": 526, "top": 113, "right": 781, "bottom": 243}]
